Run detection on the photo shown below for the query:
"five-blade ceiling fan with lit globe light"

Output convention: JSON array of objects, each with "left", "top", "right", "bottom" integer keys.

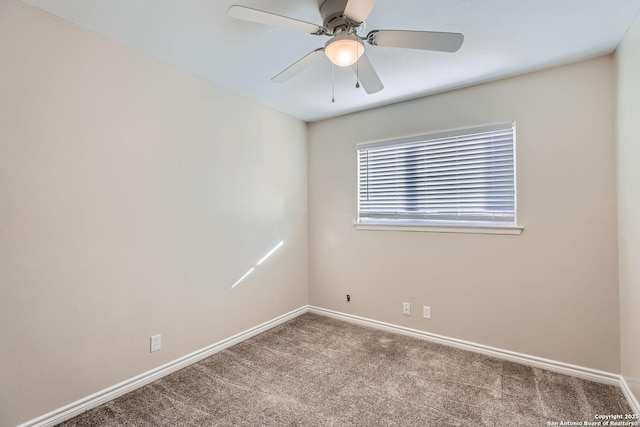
[{"left": 228, "top": 0, "right": 464, "bottom": 94}]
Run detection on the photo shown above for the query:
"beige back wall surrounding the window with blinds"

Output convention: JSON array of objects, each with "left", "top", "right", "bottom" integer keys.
[{"left": 309, "top": 56, "right": 620, "bottom": 372}]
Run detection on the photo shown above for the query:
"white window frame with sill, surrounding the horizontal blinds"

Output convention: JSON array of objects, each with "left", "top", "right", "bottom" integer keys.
[{"left": 354, "top": 122, "right": 524, "bottom": 234}]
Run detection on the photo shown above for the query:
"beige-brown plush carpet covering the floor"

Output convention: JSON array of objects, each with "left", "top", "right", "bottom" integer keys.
[{"left": 62, "top": 314, "right": 631, "bottom": 427}]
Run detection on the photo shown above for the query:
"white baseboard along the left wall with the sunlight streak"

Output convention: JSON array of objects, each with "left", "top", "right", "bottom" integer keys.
[{"left": 18, "top": 306, "right": 309, "bottom": 427}]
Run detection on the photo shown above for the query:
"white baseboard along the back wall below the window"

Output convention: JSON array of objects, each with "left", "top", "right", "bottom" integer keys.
[{"left": 309, "top": 306, "right": 621, "bottom": 387}]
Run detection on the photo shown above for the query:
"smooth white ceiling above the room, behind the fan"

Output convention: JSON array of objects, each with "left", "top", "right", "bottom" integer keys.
[{"left": 23, "top": 0, "right": 640, "bottom": 121}]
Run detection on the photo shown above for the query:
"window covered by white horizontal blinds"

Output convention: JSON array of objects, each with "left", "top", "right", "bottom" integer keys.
[{"left": 356, "top": 123, "right": 521, "bottom": 233}]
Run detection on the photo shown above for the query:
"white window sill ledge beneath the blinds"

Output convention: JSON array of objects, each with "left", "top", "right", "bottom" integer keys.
[{"left": 354, "top": 222, "right": 524, "bottom": 235}]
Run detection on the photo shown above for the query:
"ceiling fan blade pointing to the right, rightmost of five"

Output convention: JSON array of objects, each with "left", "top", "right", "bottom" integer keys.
[{"left": 367, "top": 30, "right": 464, "bottom": 52}]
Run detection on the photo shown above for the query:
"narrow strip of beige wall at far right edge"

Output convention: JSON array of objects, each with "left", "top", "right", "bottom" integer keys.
[{"left": 616, "top": 10, "right": 640, "bottom": 408}]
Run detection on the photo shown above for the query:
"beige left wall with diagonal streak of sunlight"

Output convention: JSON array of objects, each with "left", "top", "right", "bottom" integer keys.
[{"left": 0, "top": 0, "right": 308, "bottom": 426}]
